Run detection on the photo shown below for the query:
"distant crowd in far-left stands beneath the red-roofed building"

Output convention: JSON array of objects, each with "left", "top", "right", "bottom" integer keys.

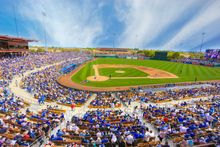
[{"left": 0, "top": 52, "right": 85, "bottom": 86}]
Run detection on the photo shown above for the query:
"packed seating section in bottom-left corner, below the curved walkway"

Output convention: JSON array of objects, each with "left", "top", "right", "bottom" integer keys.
[{"left": 0, "top": 105, "right": 64, "bottom": 146}]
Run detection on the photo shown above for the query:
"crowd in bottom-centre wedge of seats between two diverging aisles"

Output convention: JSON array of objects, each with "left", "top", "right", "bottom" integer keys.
[{"left": 50, "top": 109, "right": 160, "bottom": 147}]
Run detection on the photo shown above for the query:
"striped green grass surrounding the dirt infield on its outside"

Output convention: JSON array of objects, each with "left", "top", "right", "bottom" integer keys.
[{"left": 72, "top": 58, "right": 220, "bottom": 87}]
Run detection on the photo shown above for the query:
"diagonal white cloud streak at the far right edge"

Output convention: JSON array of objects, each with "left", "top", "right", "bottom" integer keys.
[{"left": 165, "top": 1, "right": 220, "bottom": 48}]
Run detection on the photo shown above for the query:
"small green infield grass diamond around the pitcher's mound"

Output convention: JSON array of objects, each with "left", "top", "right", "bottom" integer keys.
[{"left": 99, "top": 68, "right": 148, "bottom": 77}]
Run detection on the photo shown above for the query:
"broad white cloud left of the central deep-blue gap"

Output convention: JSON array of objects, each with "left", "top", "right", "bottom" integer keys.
[{"left": 19, "top": 0, "right": 102, "bottom": 47}]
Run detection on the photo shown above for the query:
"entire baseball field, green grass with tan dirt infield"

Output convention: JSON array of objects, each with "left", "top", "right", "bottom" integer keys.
[{"left": 58, "top": 58, "right": 220, "bottom": 88}]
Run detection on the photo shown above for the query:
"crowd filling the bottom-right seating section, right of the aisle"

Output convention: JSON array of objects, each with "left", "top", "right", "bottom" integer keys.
[{"left": 142, "top": 96, "right": 220, "bottom": 146}]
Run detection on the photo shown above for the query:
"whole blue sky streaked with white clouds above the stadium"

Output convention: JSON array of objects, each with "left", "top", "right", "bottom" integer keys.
[{"left": 0, "top": 0, "right": 220, "bottom": 51}]
